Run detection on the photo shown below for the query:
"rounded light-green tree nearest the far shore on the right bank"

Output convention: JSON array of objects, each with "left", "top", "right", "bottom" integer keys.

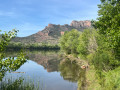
[{"left": 60, "top": 29, "right": 80, "bottom": 54}]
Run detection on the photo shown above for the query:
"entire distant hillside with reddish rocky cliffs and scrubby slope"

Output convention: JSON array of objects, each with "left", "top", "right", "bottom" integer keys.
[{"left": 12, "top": 20, "right": 91, "bottom": 44}]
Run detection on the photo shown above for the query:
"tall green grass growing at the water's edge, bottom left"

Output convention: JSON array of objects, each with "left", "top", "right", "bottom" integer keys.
[{"left": 0, "top": 77, "right": 43, "bottom": 90}]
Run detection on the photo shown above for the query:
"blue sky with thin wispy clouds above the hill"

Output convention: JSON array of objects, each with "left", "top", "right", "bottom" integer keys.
[{"left": 0, "top": 0, "right": 100, "bottom": 37}]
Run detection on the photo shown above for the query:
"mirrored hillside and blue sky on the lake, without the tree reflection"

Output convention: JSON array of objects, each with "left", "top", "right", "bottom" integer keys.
[{"left": 3, "top": 51, "right": 77, "bottom": 90}]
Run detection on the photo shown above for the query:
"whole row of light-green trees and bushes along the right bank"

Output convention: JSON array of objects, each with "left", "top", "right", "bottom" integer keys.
[{"left": 60, "top": 29, "right": 120, "bottom": 70}]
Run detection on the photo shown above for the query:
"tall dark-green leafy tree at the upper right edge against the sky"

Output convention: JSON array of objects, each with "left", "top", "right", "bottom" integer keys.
[{"left": 95, "top": 0, "right": 120, "bottom": 58}]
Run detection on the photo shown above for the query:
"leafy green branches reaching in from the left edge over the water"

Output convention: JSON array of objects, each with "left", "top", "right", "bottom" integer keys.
[{"left": 0, "top": 29, "right": 26, "bottom": 80}]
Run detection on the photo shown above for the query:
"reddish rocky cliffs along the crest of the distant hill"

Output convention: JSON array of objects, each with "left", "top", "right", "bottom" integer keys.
[{"left": 38, "top": 20, "right": 91, "bottom": 37}]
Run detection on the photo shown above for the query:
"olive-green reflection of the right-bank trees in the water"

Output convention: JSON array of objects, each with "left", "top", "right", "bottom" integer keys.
[{"left": 59, "top": 59, "right": 86, "bottom": 90}]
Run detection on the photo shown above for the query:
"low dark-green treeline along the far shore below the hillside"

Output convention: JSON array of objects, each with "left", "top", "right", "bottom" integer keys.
[{"left": 7, "top": 42, "right": 60, "bottom": 50}]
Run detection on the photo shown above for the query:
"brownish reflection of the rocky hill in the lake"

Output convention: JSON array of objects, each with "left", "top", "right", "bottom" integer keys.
[{"left": 28, "top": 52, "right": 61, "bottom": 72}]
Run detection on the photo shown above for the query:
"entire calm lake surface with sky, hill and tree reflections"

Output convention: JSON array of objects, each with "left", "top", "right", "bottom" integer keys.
[{"left": 4, "top": 51, "right": 85, "bottom": 90}]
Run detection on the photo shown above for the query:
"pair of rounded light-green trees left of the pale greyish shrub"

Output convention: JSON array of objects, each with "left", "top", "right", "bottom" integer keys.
[{"left": 60, "top": 29, "right": 97, "bottom": 58}]
